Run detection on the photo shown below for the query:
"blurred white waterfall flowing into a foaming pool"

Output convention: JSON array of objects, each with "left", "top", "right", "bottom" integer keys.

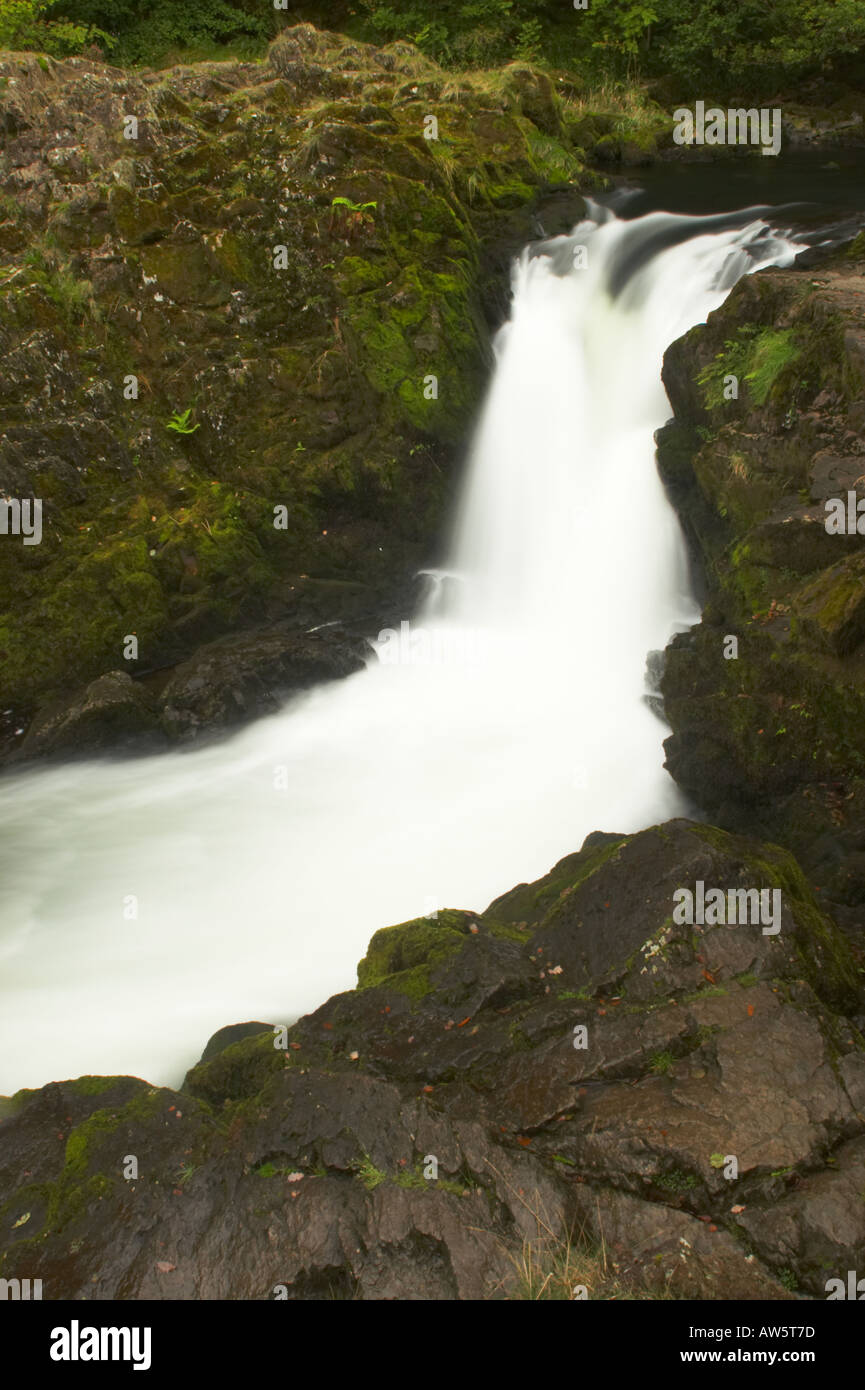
[{"left": 0, "top": 213, "right": 794, "bottom": 1091}]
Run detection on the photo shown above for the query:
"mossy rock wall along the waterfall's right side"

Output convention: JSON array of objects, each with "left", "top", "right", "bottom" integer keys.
[{"left": 659, "top": 236, "right": 865, "bottom": 938}]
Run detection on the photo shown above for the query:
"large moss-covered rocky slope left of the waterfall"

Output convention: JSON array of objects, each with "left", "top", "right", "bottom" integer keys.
[{"left": 0, "top": 25, "right": 589, "bottom": 752}]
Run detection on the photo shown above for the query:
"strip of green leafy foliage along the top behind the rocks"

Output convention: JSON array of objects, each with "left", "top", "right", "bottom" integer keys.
[{"left": 0, "top": 0, "right": 865, "bottom": 91}]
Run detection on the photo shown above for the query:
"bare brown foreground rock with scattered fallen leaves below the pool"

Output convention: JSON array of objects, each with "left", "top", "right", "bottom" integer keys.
[{"left": 0, "top": 821, "right": 865, "bottom": 1298}]
